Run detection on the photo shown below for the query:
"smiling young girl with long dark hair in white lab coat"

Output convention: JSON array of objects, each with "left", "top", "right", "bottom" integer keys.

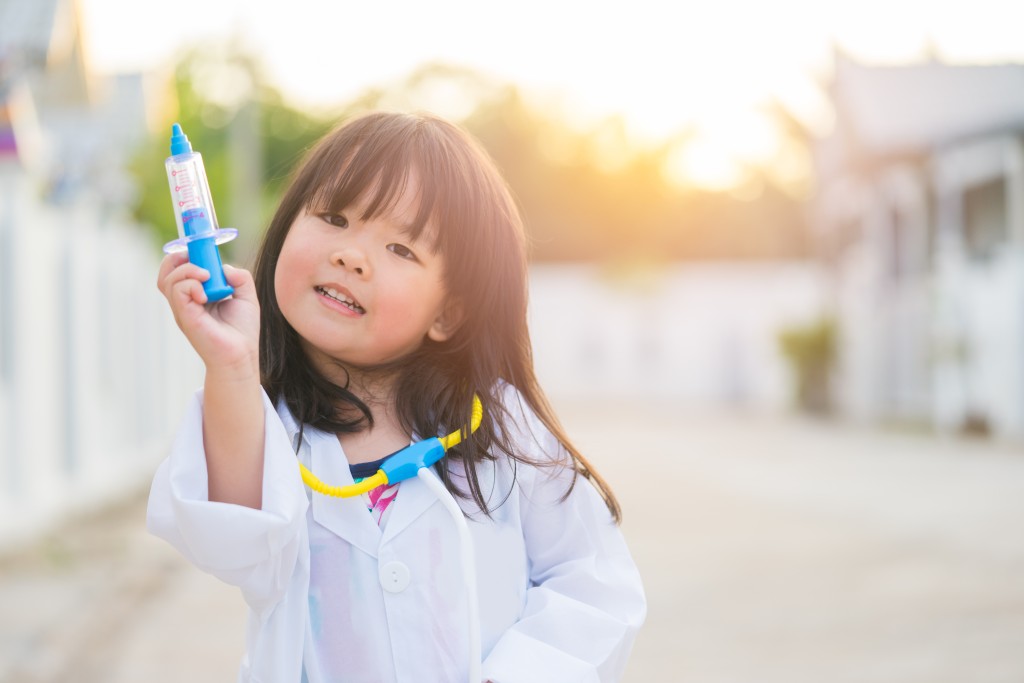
[{"left": 148, "top": 109, "right": 645, "bottom": 683}]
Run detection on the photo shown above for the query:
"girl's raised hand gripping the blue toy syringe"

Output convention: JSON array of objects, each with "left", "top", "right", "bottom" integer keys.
[{"left": 157, "top": 252, "right": 259, "bottom": 379}]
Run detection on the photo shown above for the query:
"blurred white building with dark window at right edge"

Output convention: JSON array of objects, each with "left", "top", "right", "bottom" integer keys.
[{"left": 812, "top": 54, "right": 1024, "bottom": 438}]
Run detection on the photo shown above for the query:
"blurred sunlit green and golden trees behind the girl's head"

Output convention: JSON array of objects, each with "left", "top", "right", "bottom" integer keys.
[{"left": 128, "top": 56, "right": 807, "bottom": 262}]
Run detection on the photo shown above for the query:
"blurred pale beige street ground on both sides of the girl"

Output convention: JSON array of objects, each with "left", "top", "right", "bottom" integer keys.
[{"left": 0, "top": 401, "right": 1024, "bottom": 683}]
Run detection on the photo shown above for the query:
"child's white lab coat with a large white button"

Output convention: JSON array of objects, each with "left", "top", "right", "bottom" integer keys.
[{"left": 147, "top": 387, "right": 646, "bottom": 683}]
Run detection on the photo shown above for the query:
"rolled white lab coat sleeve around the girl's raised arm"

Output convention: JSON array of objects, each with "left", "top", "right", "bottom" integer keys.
[{"left": 146, "top": 392, "right": 308, "bottom": 612}]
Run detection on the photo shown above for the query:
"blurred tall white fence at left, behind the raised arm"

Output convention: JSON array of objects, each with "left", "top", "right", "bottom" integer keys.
[{"left": 0, "top": 168, "right": 201, "bottom": 546}]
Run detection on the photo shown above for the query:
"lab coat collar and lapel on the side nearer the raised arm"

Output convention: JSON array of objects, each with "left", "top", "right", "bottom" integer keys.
[{"left": 309, "top": 430, "right": 382, "bottom": 557}]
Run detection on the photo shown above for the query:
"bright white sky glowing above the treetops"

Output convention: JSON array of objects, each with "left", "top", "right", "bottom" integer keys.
[{"left": 78, "top": 0, "right": 1024, "bottom": 184}]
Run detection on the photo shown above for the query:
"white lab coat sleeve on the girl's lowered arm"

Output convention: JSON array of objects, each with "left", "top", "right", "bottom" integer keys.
[{"left": 482, "top": 395, "right": 646, "bottom": 683}]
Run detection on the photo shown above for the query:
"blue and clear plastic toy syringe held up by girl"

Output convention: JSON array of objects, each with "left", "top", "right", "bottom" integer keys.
[{"left": 164, "top": 124, "right": 239, "bottom": 302}]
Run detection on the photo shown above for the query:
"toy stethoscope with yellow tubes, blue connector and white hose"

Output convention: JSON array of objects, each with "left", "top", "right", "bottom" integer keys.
[{"left": 296, "top": 395, "right": 483, "bottom": 683}]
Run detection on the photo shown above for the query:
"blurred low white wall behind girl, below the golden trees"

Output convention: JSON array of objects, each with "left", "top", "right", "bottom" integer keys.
[{"left": 530, "top": 263, "right": 824, "bottom": 410}]
